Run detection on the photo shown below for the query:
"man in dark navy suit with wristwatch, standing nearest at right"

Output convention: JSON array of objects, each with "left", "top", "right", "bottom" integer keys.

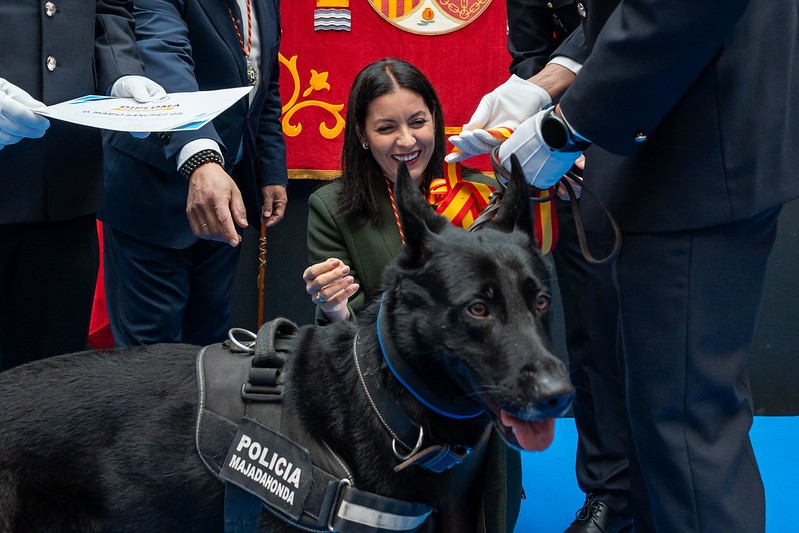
[{"left": 454, "top": 0, "right": 799, "bottom": 532}]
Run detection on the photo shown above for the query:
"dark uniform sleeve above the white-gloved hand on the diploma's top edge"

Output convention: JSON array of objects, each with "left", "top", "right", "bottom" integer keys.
[{"left": 94, "top": 0, "right": 144, "bottom": 94}]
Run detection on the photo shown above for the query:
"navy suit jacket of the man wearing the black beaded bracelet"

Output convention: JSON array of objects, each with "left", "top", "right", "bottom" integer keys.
[{"left": 100, "top": 0, "right": 288, "bottom": 248}]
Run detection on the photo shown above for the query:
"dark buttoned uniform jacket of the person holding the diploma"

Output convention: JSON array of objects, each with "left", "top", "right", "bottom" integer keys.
[{"left": 0, "top": 0, "right": 143, "bottom": 224}]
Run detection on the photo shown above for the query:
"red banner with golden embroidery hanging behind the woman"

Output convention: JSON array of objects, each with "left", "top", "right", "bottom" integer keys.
[{"left": 280, "top": 0, "right": 510, "bottom": 178}]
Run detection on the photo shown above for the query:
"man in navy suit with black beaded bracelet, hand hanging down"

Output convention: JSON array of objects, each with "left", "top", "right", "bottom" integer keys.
[{"left": 100, "top": 0, "right": 288, "bottom": 346}]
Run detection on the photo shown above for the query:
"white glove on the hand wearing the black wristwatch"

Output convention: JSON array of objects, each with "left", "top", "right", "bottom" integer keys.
[{"left": 499, "top": 109, "right": 582, "bottom": 189}]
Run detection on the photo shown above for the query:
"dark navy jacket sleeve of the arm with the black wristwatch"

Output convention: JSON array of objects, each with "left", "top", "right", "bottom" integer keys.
[{"left": 560, "top": 0, "right": 756, "bottom": 155}]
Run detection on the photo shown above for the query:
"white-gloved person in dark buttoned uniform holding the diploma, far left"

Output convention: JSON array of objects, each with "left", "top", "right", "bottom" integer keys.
[{"left": 0, "top": 0, "right": 162, "bottom": 370}]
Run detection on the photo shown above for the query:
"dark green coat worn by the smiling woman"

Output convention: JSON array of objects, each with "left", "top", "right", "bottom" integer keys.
[{"left": 308, "top": 174, "right": 522, "bottom": 533}]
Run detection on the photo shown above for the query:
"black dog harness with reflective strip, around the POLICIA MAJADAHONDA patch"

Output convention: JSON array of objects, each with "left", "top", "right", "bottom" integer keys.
[{"left": 200, "top": 321, "right": 432, "bottom": 533}]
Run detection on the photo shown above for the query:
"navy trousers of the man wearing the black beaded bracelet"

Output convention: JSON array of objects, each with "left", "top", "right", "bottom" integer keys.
[{"left": 103, "top": 224, "right": 240, "bottom": 347}]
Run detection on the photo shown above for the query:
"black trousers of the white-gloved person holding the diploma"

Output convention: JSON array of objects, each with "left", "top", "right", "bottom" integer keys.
[{"left": 0, "top": 215, "right": 99, "bottom": 370}]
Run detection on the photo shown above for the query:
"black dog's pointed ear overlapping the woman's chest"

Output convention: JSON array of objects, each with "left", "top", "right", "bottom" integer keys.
[{"left": 394, "top": 163, "right": 450, "bottom": 259}]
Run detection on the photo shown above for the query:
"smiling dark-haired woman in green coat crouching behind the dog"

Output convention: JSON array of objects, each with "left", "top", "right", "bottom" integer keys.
[{"left": 303, "top": 59, "right": 492, "bottom": 323}]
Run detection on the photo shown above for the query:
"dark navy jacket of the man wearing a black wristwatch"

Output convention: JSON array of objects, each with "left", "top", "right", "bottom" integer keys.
[{"left": 560, "top": 0, "right": 799, "bottom": 232}]
